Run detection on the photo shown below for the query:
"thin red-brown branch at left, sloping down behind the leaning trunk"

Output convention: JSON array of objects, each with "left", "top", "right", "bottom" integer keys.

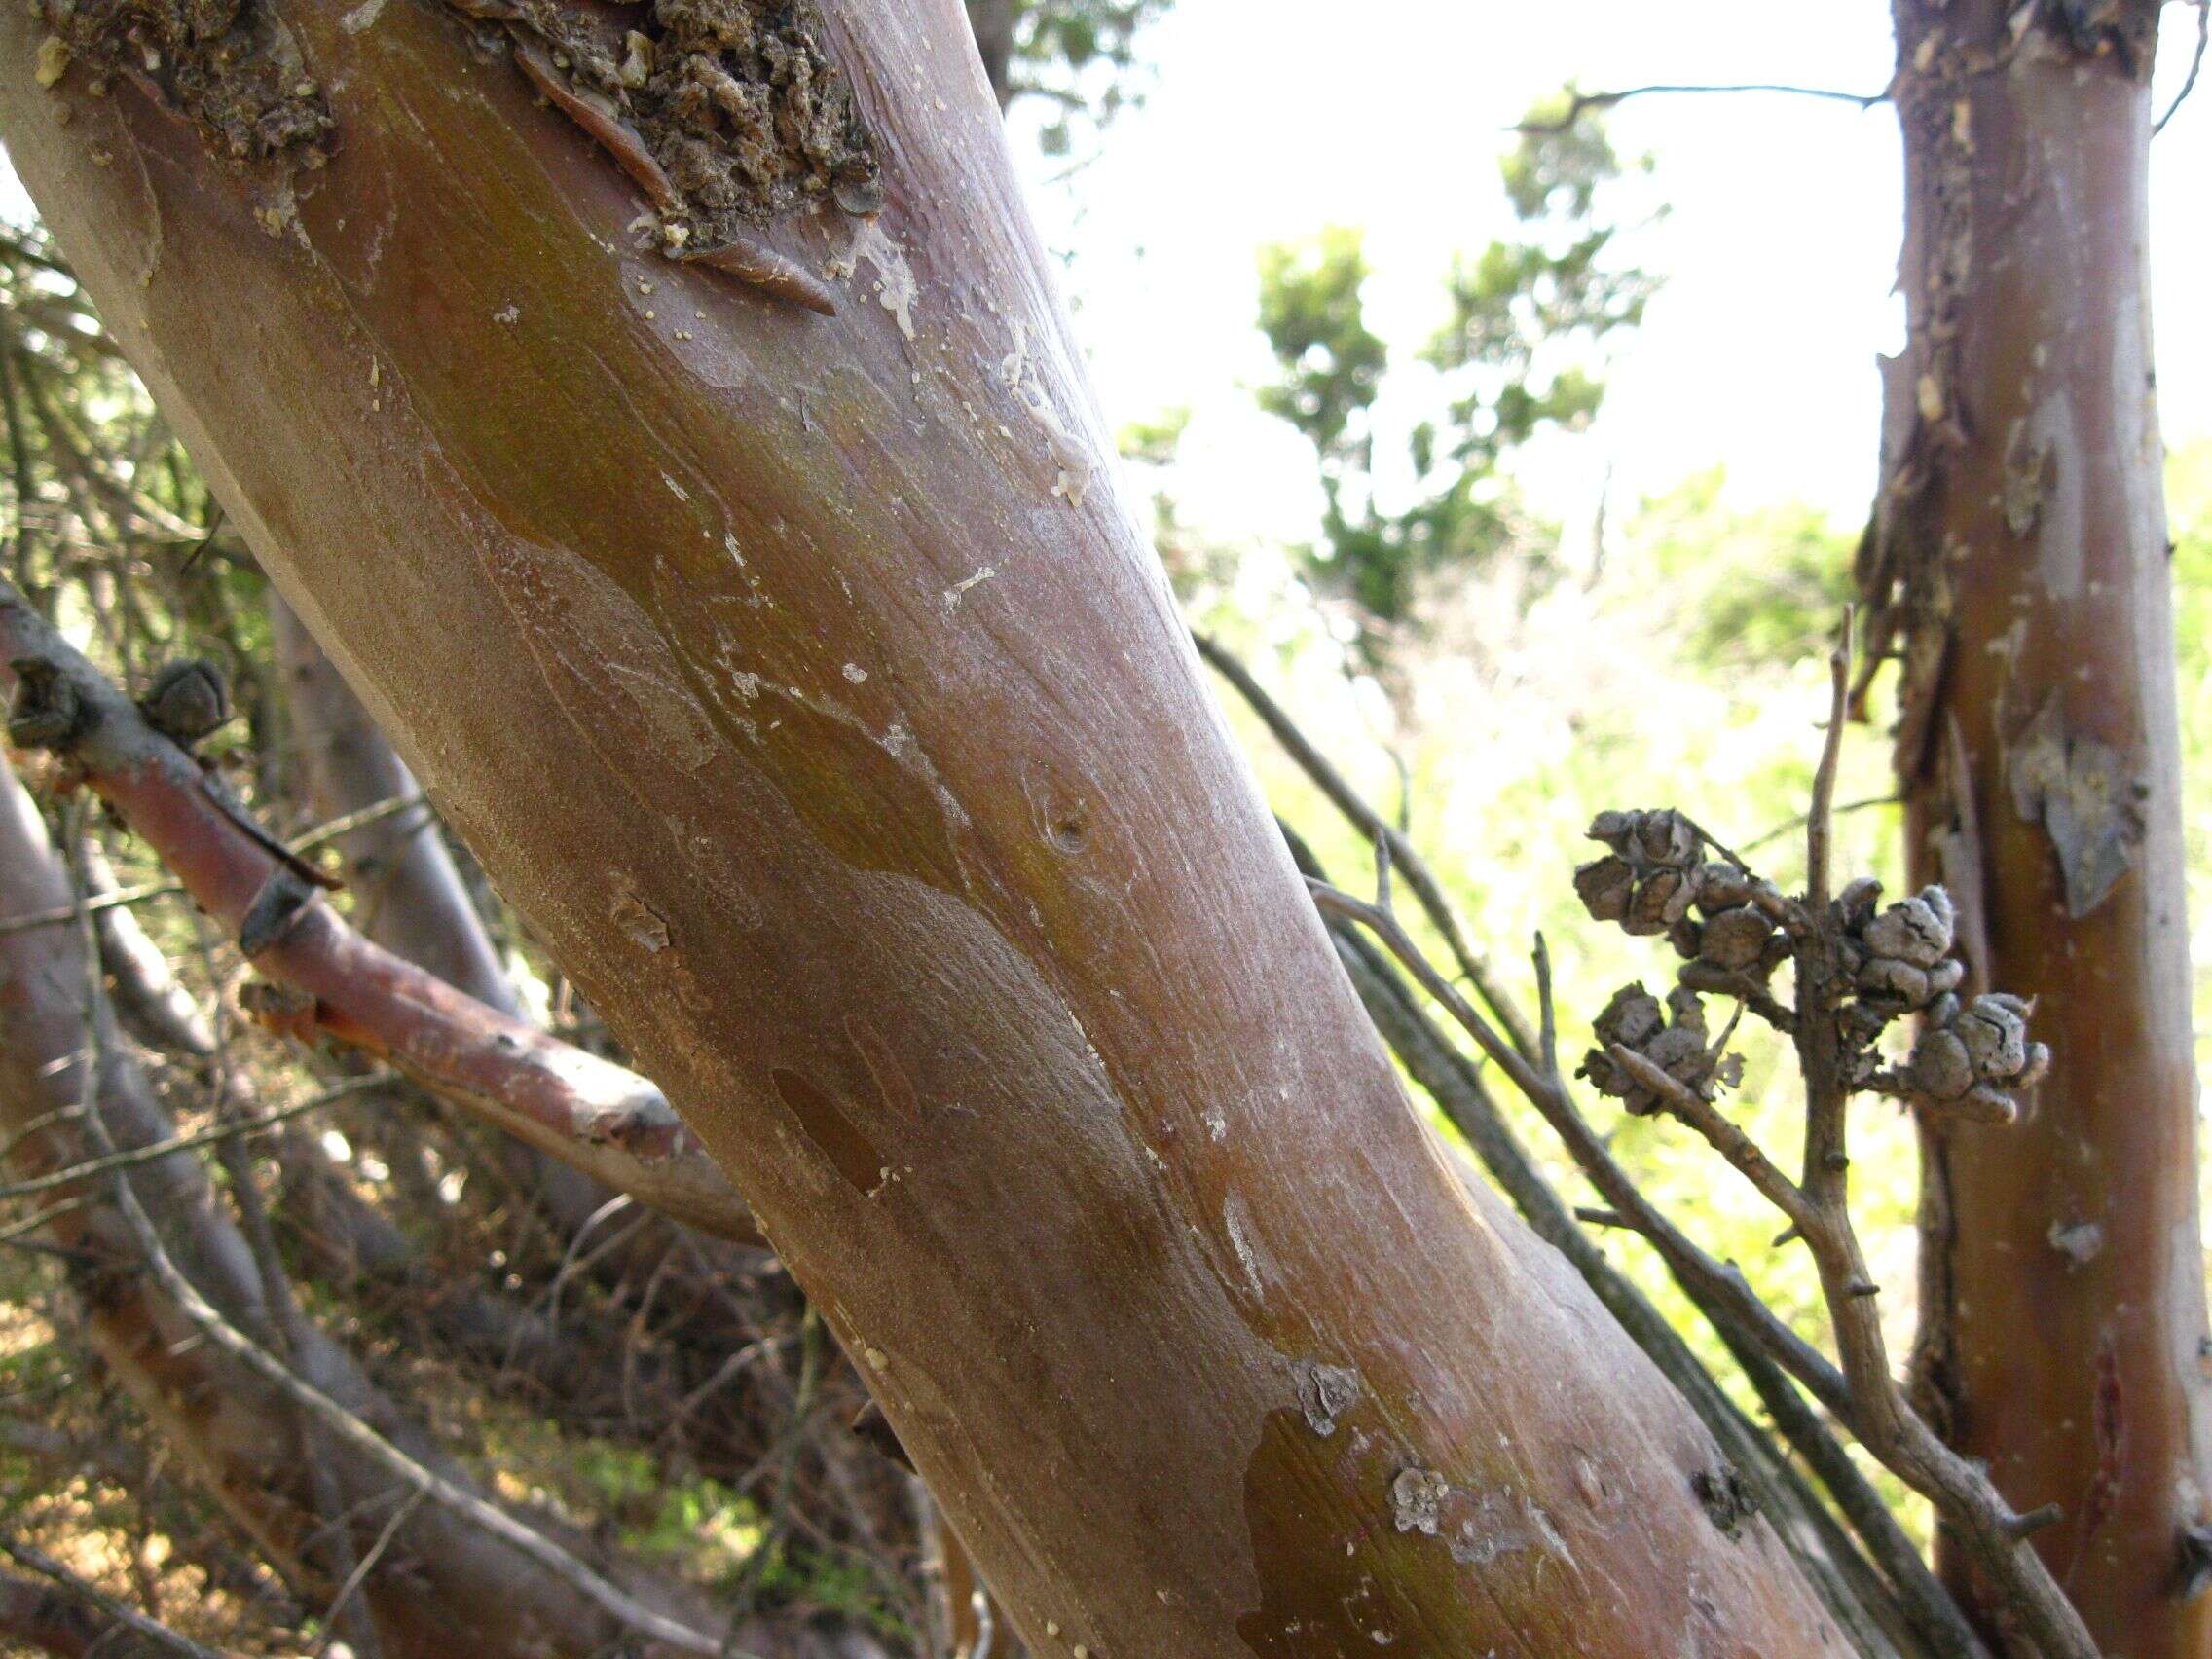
[{"left": 0, "top": 588, "right": 761, "bottom": 1243}]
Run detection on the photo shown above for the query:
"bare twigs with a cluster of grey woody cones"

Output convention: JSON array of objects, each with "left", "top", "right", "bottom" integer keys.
[{"left": 1208, "top": 635, "right": 2097, "bottom": 1659}]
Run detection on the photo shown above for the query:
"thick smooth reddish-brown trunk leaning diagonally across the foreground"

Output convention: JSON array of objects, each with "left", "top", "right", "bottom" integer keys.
[{"left": 0, "top": 0, "right": 1840, "bottom": 1659}]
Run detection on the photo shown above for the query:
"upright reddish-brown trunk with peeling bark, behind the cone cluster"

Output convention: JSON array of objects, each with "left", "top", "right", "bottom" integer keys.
[{"left": 1861, "top": 0, "right": 2212, "bottom": 1659}]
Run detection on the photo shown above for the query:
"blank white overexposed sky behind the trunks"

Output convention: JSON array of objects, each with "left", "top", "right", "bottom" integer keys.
[{"left": 1017, "top": 0, "right": 2212, "bottom": 539}]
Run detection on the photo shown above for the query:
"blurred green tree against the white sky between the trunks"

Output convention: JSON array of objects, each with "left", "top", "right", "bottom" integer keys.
[{"left": 1259, "top": 100, "right": 1657, "bottom": 685}]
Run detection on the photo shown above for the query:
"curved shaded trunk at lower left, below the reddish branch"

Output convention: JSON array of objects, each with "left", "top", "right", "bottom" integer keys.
[{"left": 0, "top": 772, "right": 760, "bottom": 1659}]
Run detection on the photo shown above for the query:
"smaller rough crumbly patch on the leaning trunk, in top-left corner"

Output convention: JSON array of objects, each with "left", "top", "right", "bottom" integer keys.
[{"left": 31, "top": 0, "right": 332, "bottom": 168}]
